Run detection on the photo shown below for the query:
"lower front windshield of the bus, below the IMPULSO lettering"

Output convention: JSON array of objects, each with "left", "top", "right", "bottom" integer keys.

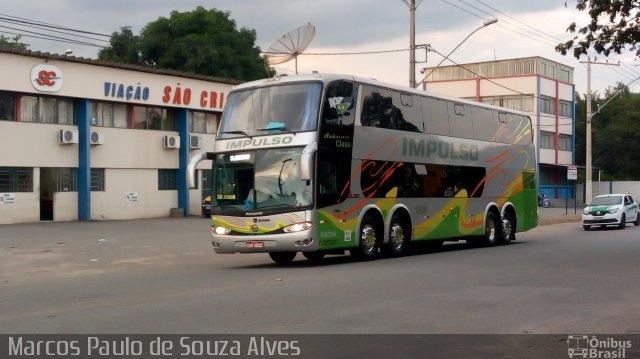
[{"left": 211, "top": 147, "right": 313, "bottom": 214}]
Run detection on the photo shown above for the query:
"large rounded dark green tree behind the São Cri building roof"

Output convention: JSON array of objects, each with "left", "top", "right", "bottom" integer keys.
[{"left": 98, "top": 6, "right": 270, "bottom": 80}]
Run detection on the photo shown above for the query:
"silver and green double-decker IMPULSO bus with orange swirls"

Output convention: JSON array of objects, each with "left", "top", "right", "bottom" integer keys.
[{"left": 188, "top": 73, "right": 538, "bottom": 264}]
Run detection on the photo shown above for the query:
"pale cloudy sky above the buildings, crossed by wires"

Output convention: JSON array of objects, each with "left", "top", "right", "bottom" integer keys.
[{"left": 0, "top": 0, "right": 640, "bottom": 94}]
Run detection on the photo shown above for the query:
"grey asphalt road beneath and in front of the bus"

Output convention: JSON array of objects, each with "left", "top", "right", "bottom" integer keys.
[{"left": 0, "top": 217, "right": 640, "bottom": 334}]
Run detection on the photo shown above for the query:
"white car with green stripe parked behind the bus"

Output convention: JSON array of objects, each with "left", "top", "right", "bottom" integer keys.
[{"left": 582, "top": 194, "right": 640, "bottom": 231}]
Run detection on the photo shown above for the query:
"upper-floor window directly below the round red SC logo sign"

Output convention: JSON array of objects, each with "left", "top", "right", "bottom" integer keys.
[{"left": 20, "top": 96, "right": 75, "bottom": 125}]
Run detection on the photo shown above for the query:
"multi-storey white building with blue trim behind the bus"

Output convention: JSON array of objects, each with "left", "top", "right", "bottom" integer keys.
[{"left": 424, "top": 57, "right": 575, "bottom": 199}]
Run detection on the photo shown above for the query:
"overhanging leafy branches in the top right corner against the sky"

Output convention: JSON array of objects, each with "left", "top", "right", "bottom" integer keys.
[{"left": 556, "top": 0, "right": 640, "bottom": 58}]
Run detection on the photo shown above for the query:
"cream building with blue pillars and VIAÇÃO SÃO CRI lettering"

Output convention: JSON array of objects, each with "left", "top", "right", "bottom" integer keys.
[{"left": 0, "top": 50, "right": 238, "bottom": 224}]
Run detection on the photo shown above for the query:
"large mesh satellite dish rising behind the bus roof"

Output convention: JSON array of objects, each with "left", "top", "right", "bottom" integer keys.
[{"left": 267, "top": 24, "right": 316, "bottom": 75}]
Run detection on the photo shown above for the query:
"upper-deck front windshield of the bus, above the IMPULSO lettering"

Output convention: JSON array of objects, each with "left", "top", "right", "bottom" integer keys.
[{"left": 218, "top": 82, "right": 322, "bottom": 139}]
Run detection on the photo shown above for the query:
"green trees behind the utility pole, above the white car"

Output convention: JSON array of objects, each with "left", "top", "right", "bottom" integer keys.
[{"left": 576, "top": 83, "right": 640, "bottom": 180}]
